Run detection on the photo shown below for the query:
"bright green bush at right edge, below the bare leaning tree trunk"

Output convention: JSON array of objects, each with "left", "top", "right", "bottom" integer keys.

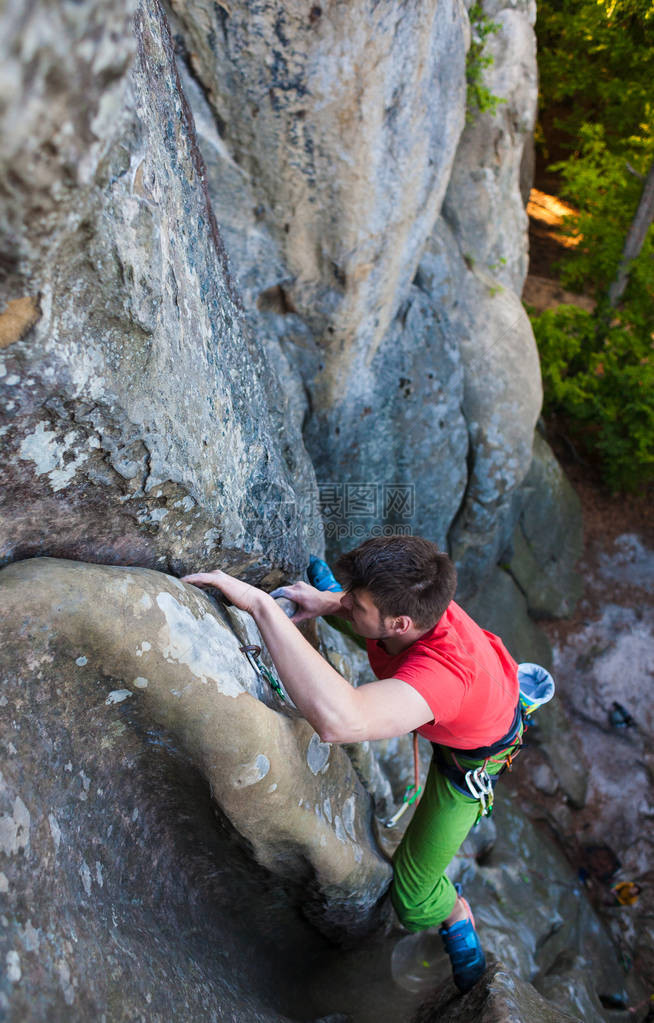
[{"left": 532, "top": 306, "right": 654, "bottom": 491}]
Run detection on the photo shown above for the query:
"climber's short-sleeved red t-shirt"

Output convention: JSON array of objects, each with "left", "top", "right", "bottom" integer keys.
[{"left": 366, "top": 601, "right": 519, "bottom": 750}]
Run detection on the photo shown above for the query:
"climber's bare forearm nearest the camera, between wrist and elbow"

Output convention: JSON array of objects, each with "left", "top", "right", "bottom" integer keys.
[{"left": 251, "top": 592, "right": 363, "bottom": 742}]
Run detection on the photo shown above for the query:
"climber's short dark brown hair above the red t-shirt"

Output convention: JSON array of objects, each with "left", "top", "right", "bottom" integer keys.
[{"left": 335, "top": 536, "right": 456, "bottom": 629}]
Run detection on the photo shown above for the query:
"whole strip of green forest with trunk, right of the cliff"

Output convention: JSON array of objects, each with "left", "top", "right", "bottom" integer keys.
[{"left": 529, "top": 0, "right": 654, "bottom": 492}]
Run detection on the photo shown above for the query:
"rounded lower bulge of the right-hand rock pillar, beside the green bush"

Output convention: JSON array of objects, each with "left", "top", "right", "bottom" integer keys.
[{"left": 417, "top": 221, "right": 541, "bottom": 599}]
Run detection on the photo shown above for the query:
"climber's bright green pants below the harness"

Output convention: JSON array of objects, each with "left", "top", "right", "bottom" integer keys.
[{"left": 391, "top": 729, "right": 522, "bottom": 931}]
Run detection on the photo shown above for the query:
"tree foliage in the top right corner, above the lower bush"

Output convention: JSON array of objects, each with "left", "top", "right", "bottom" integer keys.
[{"left": 536, "top": 0, "right": 654, "bottom": 315}]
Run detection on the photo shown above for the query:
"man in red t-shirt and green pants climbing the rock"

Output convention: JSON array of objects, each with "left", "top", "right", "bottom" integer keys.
[{"left": 184, "top": 536, "right": 522, "bottom": 991}]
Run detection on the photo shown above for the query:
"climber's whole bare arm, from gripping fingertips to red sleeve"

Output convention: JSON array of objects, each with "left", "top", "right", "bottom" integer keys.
[{"left": 183, "top": 571, "right": 434, "bottom": 743}]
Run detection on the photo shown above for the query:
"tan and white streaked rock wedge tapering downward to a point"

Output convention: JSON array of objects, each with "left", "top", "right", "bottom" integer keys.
[{"left": 173, "top": 0, "right": 467, "bottom": 384}]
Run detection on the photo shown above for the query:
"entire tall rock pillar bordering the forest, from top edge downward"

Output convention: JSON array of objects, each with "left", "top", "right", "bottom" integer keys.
[{"left": 418, "top": 0, "right": 541, "bottom": 599}]
